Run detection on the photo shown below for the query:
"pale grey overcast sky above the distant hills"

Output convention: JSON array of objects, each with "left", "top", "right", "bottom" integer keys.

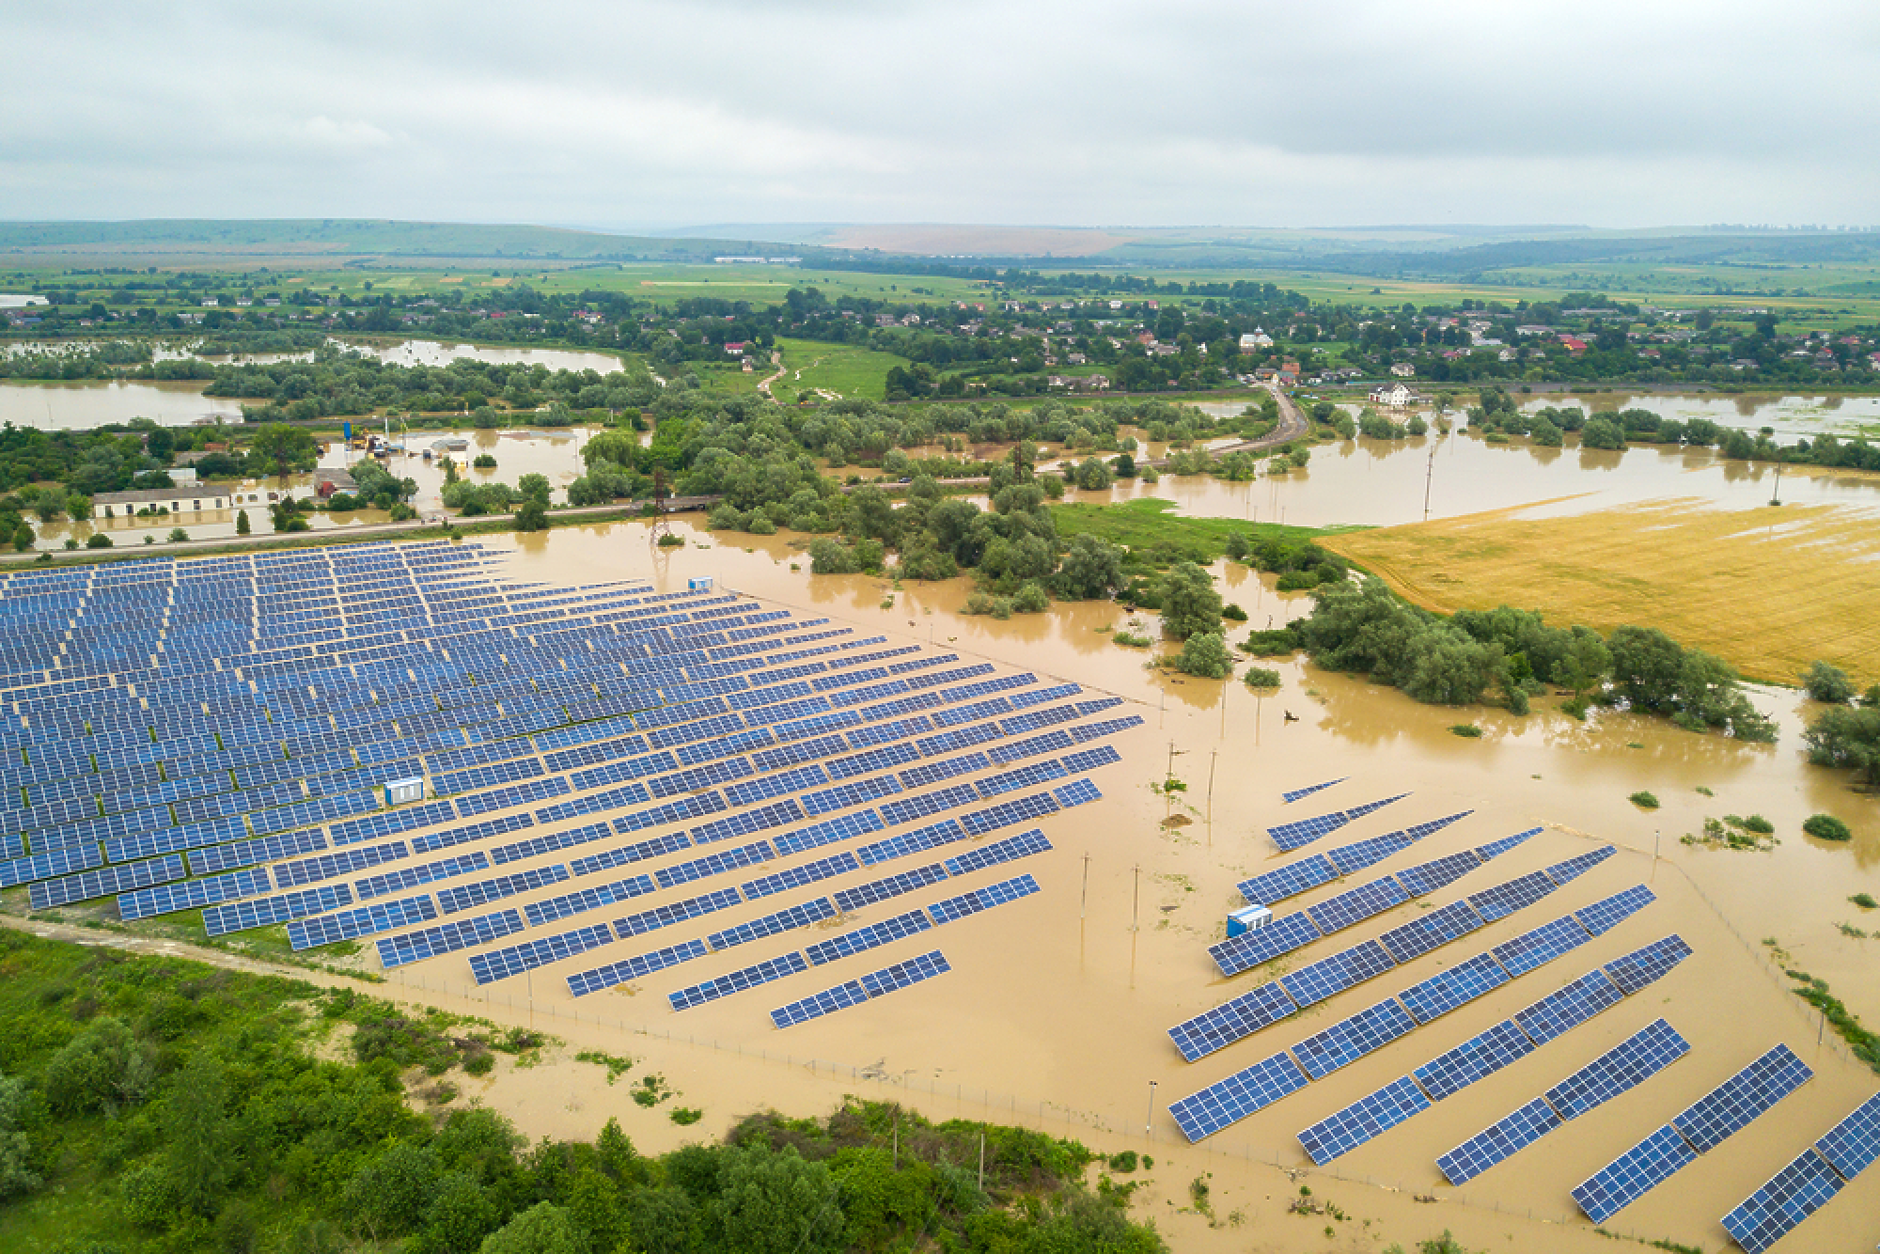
[{"left": 0, "top": 0, "right": 1880, "bottom": 227}]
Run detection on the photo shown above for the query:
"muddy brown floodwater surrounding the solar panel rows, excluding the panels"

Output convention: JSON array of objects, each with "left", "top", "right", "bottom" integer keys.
[{"left": 300, "top": 521, "right": 1880, "bottom": 1252}]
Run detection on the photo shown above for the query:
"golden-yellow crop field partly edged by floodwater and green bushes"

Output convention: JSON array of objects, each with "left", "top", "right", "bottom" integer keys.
[{"left": 1318, "top": 500, "right": 1880, "bottom": 686}]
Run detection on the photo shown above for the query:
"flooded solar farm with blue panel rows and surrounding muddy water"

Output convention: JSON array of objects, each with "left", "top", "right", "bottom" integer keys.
[{"left": 0, "top": 523, "right": 1880, "bottom": 1250}]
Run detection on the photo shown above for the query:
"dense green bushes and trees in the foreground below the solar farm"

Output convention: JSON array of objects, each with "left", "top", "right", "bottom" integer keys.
[{"left": 0, "top": 931, "right": 1166, "bottom": 1254}]
